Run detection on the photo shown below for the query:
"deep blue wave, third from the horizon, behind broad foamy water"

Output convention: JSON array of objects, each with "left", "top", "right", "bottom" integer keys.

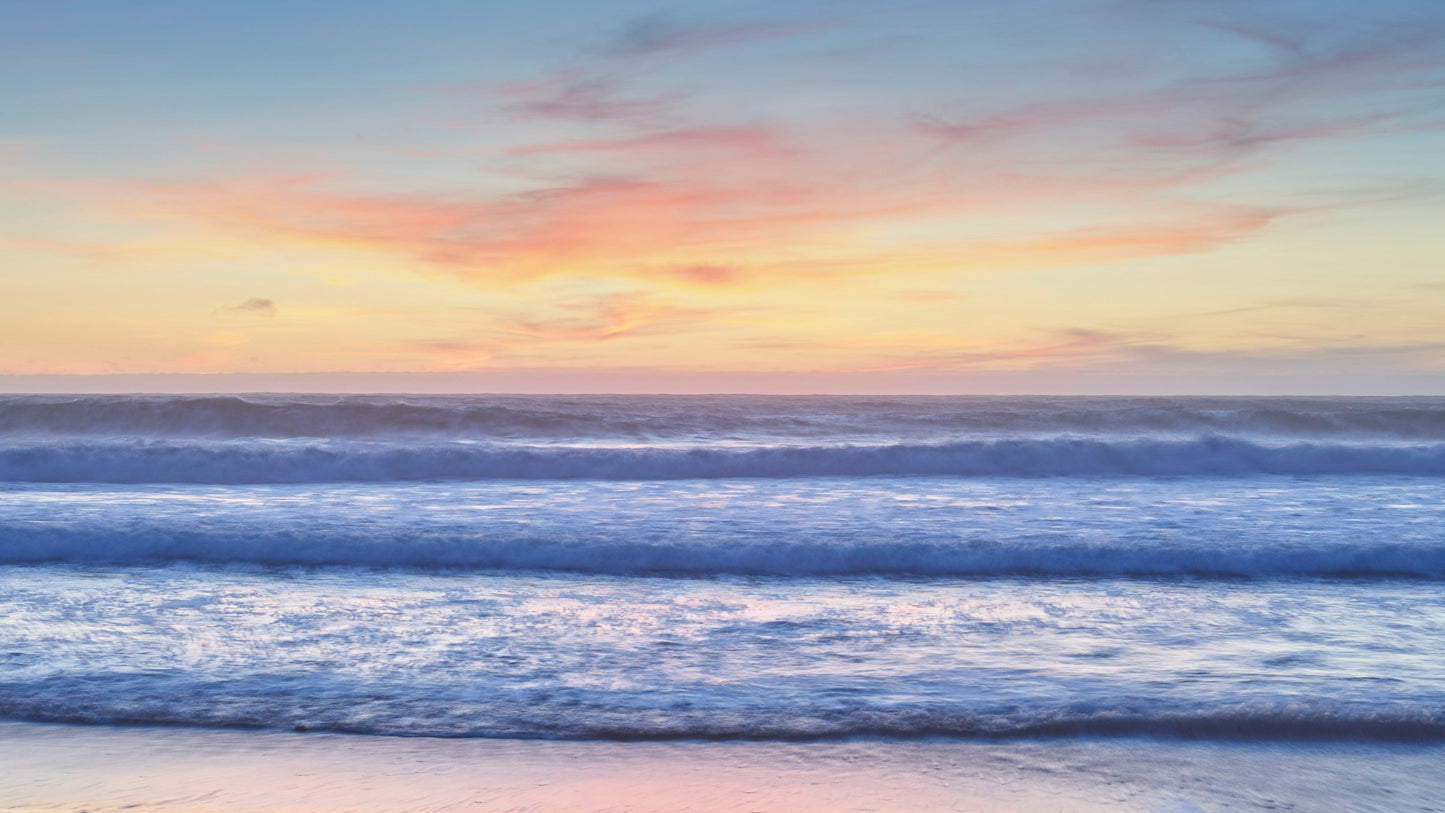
[{"left": 0, "top": 523, "right": 1445, "bottom": 579}]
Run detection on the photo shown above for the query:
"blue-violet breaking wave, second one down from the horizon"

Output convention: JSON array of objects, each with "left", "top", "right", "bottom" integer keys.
[{"left": 0, "top": 436, "right": 1445, "bottom": 484}]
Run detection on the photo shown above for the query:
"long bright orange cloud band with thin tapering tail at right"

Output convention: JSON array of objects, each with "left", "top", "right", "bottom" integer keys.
[{"left": 140, "top": 161, "right": 1287, "bottom": 284}]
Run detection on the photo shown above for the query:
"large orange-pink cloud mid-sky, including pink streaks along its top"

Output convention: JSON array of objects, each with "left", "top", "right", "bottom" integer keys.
[{"left": 137, "top": 129, "right": 1267, "bottom": 286}]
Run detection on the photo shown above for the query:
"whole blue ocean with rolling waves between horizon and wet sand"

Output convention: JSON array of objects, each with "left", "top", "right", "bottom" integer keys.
[{"left": 0, "top": 394, "right": 1445, "bottom": 810}]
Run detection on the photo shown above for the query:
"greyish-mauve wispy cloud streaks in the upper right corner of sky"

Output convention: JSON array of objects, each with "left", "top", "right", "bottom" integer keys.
[{"left": 915, "top": 3, "right": 1445, "bottom": 169}]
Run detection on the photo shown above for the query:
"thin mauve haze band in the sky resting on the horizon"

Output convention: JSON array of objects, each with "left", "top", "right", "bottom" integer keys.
[{"left": 0, "top": 368, "right": 1445, "bottom": 399}]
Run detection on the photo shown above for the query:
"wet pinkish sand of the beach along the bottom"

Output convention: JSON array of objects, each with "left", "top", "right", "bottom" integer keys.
[{"left": 0, "top": 722, "right": 1445, "bottom": 813}]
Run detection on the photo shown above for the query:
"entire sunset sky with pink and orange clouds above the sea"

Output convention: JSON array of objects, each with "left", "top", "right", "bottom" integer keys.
[{"left": 0, "top": 0, "right": 1445, "bottom": 394}]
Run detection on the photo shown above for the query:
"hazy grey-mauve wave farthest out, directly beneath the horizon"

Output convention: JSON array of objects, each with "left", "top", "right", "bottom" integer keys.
[{"left": 0, "top": 396, "right": 1445, "bottom": 440}]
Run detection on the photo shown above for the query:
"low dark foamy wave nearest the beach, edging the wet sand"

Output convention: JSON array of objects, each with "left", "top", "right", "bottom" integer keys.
[{"left": 0, "top": 682, "right": 1445, "bottom": 742}]
